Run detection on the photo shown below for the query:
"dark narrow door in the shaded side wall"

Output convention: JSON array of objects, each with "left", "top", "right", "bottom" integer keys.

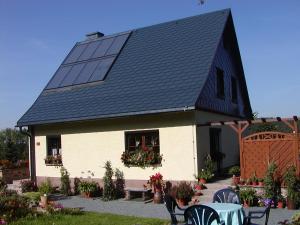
[{"left": 209, "top": 128, "right": 223, "bottom": 173}]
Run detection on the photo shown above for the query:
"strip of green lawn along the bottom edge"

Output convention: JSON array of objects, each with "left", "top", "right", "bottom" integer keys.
[{"left": 10, "top": 212, "right": 170, "bottom": 225}]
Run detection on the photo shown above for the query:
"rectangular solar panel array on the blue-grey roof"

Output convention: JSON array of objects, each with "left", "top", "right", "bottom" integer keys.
[{"left": 46, "top": 33, "right": 130, "bottom": 89}]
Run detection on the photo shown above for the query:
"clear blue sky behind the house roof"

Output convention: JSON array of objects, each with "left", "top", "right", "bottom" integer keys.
[{"left": 0, "top": 0, "right": 300, "bottom": 128}]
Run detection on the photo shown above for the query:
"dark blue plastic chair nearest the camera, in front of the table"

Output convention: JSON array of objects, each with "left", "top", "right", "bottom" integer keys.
[{"left": 184, "top": 205, "right": 225, "bottom": 225}]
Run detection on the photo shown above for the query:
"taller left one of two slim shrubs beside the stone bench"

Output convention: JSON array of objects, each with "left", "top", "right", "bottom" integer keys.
[{"left": 103, "top": 161, "right": 115, "bottom": 201}]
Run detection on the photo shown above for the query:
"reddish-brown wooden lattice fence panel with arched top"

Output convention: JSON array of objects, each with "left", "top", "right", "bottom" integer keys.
[{"left": 241, "top": 132, "right": 300, "bottom": 178}]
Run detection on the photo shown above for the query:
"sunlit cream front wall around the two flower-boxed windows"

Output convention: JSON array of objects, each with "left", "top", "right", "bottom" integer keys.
[{"left": 35, "top": 112, "right": 197, "bottom": 180}]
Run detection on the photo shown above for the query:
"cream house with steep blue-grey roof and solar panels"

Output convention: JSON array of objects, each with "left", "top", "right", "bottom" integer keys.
[{"left": 17, "top": 9, "right": 252, "bottom": 186}]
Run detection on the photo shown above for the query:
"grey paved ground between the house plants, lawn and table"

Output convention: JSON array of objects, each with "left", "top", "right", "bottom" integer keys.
[{"left": 58, "top": 196, "right": 300, "bottom": 225}]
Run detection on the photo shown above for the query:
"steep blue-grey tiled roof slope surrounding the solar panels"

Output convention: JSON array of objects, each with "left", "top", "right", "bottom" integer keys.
[{"left": 17, "top": 9, "right": 230, "bottom": 126}]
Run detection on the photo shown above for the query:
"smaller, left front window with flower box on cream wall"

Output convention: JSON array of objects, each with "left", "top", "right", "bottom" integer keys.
[{"left": 45, "top": 136, "right": 62, "bottom": 165}]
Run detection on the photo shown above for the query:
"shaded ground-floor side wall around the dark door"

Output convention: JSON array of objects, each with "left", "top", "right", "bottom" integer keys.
[{"left": 195, "top": 111, "right": 239, "bottom": 172}]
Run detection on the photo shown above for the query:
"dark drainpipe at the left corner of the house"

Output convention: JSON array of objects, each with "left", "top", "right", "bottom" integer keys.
[{"left": 19, "top": 126, "right": 36, "bottom": 183}]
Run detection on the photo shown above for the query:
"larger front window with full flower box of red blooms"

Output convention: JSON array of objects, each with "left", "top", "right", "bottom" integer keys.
[{"left": 121, "top": 130, "right": 162, "bottom": 167}]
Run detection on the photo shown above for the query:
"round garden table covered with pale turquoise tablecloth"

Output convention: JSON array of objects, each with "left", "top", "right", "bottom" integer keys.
[{"left": 204, "top": 203, "right": 244, "bottom": 225}]
